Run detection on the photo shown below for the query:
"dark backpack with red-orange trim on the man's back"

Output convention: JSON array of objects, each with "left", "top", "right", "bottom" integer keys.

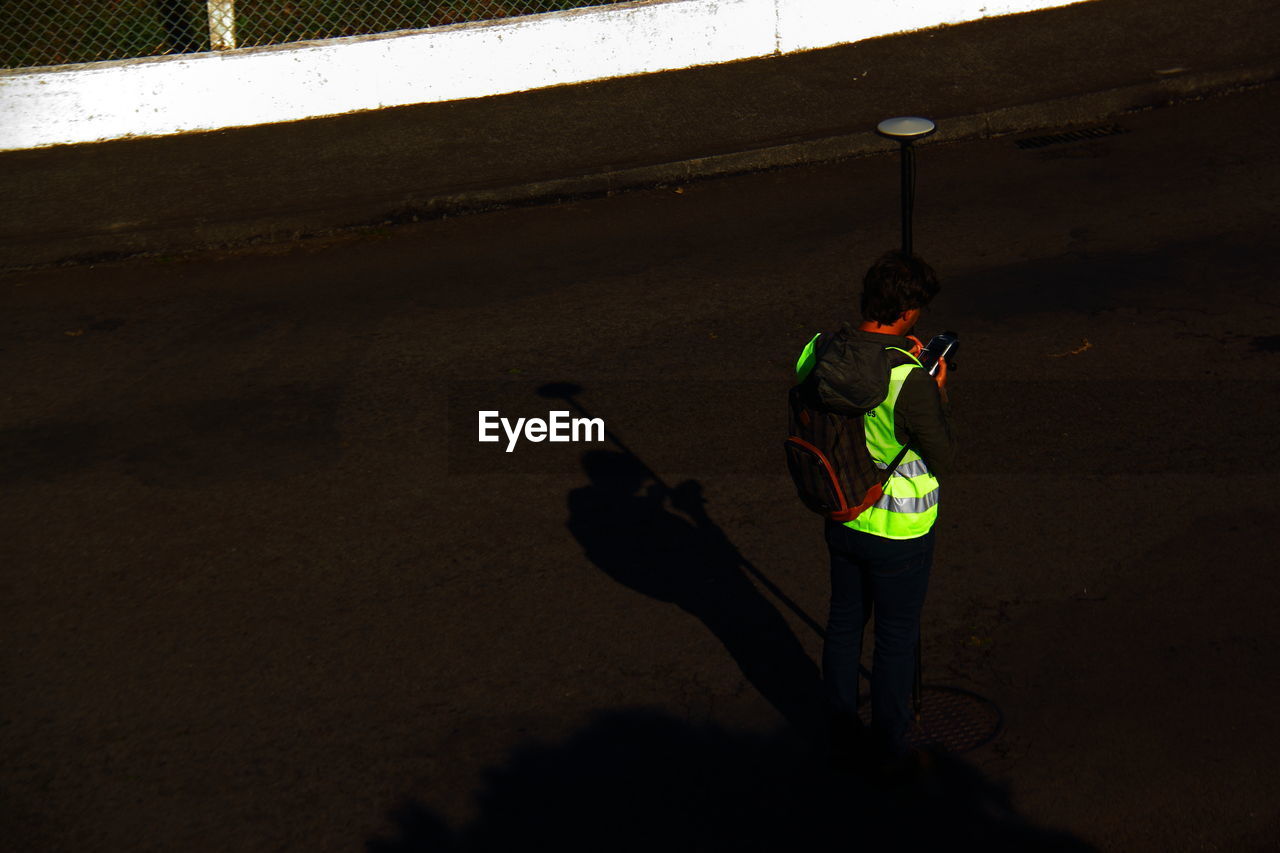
[{"left": 783, "top": 338, "right": 908, "bottom": 523}]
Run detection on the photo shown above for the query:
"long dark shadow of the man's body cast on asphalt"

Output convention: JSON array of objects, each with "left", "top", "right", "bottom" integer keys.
[{"left": 567, "top": 451, "right": 823, "bottom": 742}]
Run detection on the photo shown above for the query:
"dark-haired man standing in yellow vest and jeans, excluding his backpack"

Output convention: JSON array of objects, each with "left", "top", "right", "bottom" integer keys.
[{"left": 796, "top": 251, "right": 955, "bottom": 762}]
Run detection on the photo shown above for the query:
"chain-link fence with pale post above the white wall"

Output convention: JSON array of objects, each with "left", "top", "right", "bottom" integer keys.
[{"left": 0, "top": 0, "right": 625, "bottom": 68}]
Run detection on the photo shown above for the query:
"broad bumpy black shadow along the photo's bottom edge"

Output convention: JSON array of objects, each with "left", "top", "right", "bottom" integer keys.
[{"left": 366, "top": 710, "right": 1093, "bottom": 853}]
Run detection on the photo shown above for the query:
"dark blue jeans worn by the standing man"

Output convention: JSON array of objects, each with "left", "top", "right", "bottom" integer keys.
[{"left": 822, "top": 521, "right": 933, "bottom": 753}]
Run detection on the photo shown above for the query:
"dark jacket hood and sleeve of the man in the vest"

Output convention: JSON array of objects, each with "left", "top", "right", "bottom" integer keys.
[{"left": 813, "top": 323, "right": 955, "bottom": 479}]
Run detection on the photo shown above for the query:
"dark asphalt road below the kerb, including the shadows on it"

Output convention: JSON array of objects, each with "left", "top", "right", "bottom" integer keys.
[{"left": 0, "top": 87, "right": 1280, "bottom": 852}]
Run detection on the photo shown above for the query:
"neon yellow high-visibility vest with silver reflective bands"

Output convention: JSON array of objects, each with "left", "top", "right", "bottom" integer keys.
[{"left": 796, "top": 336, "right": 938, "bottom": 539}]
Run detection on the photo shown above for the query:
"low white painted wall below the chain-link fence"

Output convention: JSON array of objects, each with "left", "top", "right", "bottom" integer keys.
[{"left": 0, "top": 0, "right": 1084, "bottom": 151}]
